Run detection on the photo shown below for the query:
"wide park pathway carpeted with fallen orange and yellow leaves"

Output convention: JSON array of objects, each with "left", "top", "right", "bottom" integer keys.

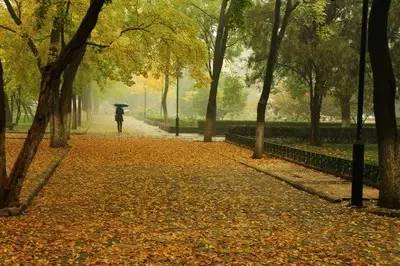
[{"left": 0, "top": 128, "right": 400, "bottom": 265}]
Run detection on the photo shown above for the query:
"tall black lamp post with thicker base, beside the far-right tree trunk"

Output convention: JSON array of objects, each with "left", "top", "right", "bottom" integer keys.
[{"left": 351, "top": 0, "right": 369, "bottom": 207}]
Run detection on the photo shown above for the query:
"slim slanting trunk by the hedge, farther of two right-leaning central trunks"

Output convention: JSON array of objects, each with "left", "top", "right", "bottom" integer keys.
[{"left": 204, "top": 0, "right": 229, "bottom": 142}]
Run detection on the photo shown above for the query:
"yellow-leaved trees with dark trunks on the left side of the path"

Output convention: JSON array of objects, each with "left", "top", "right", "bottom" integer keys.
[{"left": 0, "top": 0, "right": 212, "bottom": 207}]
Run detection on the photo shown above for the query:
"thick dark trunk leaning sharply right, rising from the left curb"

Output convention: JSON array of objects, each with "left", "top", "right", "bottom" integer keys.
[{"left": 0, "top": 0, "right": 104, "bottom": 206}]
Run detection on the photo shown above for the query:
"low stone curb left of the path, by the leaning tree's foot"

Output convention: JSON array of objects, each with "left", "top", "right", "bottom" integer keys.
[{"left": 0, "top": 148, "right": 70, "bottom": 217}]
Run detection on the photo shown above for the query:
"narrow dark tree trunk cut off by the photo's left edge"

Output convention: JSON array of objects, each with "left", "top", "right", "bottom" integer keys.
[{"left": 0, "top": 60, "right": 8, "bottom": 208}]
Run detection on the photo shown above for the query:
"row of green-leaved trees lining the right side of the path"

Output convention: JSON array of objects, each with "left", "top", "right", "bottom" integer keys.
[{"left": 190, "top": 0, "right": 400, "bottom": 208}]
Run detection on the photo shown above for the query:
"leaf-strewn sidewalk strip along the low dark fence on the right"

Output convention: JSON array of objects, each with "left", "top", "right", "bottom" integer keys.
[{"left": 208, "top": 143, "right": 379, "bottom": 202}]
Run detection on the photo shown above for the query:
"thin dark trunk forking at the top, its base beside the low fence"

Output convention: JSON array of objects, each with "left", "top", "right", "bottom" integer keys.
[{"left": 252, "top": 0, "right": 297, "bottom": 159}]
